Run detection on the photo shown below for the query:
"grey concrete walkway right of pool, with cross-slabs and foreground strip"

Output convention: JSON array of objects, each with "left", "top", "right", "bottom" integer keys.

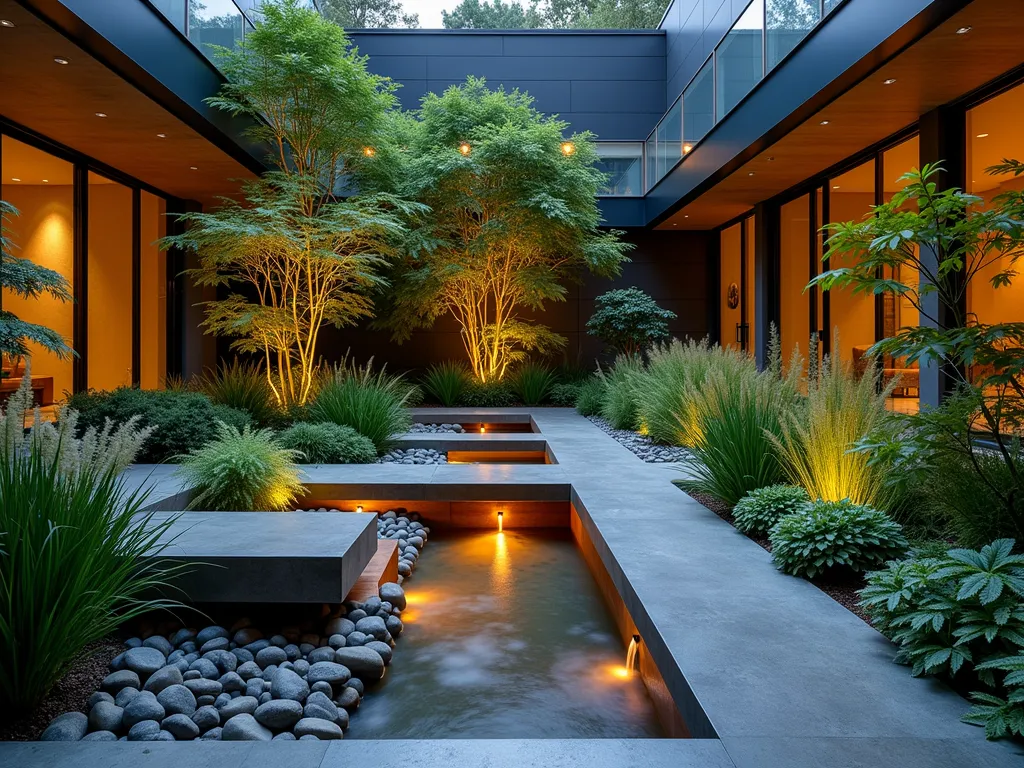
[{"left": 44, "top": 409, "right": 1024, "bottom": 768}]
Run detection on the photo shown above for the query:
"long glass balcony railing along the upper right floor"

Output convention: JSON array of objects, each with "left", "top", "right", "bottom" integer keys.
[{"left": 643, "top": 0, "right": 844, "bottom": 191}]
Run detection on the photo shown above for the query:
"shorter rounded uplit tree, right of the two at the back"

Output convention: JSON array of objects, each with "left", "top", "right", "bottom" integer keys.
[{"left": 381, "top": 78, "right": 629, "bottom": 382}]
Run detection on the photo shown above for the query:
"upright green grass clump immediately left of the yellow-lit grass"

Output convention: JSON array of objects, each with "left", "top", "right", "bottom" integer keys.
[{"left": 678, "top": 344, "right": 800, "bottom": 506}]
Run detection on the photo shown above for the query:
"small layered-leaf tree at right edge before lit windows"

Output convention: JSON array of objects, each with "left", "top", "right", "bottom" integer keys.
[{"left": 811, "top": 160, "right": 1024, "bottom": 539}]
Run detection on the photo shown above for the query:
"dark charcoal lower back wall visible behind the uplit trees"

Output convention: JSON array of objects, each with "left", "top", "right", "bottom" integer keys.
[{"left": 321, "top": 230, "right": 711, "bottom": 370}]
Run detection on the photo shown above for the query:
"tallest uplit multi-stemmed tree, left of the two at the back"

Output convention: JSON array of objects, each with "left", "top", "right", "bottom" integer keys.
[{"left": 164, "top": 0, "right": 424, "bottom": 406}]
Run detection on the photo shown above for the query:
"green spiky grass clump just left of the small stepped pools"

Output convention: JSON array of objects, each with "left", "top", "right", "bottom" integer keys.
[{"left": 308, "top": 359, "right": 413, "bottom": 454}]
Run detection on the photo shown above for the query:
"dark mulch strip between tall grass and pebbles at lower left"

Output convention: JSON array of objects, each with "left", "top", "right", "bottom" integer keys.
[{"left": 0, "top": 638, "right": 124, "bottom": 741}]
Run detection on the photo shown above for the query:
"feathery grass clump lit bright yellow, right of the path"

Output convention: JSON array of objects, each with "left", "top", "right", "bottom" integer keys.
[{"left": 771, "top": 334, "right": 895, "bottom": 507}]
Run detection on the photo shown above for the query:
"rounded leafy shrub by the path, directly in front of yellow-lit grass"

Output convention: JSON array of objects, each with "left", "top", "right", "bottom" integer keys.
[{"left": 769, "top": 499, "right": 909, "bottom": 579}]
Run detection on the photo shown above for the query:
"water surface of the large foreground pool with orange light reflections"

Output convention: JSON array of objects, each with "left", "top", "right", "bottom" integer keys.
[{"left": 346, "top": 530, "right": 662, "bottom": 738}]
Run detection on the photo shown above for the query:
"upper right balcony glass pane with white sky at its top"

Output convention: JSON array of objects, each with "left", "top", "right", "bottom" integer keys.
[{"left": 715, "top": 0, "right": 765, "bottom": 120}]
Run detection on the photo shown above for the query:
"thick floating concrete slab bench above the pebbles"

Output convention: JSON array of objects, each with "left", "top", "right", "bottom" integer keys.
[{"left": 146, "top": 512, "right": 377, "bottom": 603}]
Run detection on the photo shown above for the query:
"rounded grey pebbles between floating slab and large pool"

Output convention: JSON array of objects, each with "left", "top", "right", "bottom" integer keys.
[{"left": 35, "top": 508, "right": 430, "bottom": 741}]
